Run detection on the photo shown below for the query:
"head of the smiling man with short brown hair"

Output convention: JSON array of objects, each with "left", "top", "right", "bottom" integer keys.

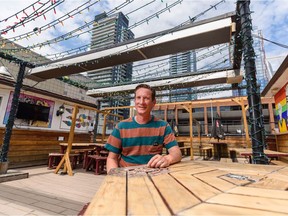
[{"left": 135, "top": 88, "right": 156, "bottom": 115}]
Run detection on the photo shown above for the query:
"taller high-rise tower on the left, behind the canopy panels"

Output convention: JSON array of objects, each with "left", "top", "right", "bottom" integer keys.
[{"left": 87, "top": 12, "right": 134, "bottom": 117}]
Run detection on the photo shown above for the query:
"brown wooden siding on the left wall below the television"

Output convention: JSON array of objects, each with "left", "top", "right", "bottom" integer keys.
[{"left": 0, "top": 128, "right": 90, "bottom": 168}]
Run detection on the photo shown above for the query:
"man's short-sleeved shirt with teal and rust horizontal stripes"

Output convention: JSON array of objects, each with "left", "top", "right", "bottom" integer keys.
[{"left": 105, "top": 116, "right": 177, "bottom": 167}]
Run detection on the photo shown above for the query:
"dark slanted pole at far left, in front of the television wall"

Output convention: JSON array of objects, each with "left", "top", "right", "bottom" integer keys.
[{"left": 0, "top": 62, "right": 27, "bottom": 165}]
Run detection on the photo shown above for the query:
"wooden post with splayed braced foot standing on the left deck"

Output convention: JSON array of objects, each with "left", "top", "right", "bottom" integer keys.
[{"left": 54, "top": 105, "right": 78, "bottom": 176}]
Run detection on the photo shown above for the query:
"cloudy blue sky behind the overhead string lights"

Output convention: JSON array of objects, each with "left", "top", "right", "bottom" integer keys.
[{"left": 0, "top": 0, "right": 288, "bottom": 69}]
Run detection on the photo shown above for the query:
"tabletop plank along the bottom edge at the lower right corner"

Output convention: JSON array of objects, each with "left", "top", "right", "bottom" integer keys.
[{"left": 178, "top": 203, "right": 287, "bottom": 216}]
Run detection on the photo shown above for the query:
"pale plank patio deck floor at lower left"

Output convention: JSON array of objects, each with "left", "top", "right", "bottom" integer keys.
[{"left": 0, "top": 166, "right": 106, "bottom": 216}]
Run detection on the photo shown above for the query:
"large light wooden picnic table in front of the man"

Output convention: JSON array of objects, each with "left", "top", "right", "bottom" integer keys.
[{"left": 84, "top": 161, "right": 288, "bottom": 215}]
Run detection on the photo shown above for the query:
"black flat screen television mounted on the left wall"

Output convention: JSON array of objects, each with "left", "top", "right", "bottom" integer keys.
[{"left": 16, "top": 102, "right": 50, "bottom": 122}]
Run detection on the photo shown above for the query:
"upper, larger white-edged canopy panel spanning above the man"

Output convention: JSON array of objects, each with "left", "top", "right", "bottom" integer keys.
[{"left": 27, "top": 12, "right": 235, "bottom": 81}]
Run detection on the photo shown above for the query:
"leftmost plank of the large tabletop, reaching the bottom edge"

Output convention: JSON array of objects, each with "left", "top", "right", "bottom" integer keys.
[{"left": 85, "top": 175, "right": 126, "bottom": 215}]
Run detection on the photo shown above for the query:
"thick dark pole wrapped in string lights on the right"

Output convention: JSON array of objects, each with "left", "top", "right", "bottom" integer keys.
[{"left": 237, "top": 0, "right": 268, "bottom": 164}]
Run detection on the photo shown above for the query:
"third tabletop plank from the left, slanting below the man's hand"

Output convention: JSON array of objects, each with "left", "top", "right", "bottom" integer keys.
[{"left": 151, "top": 174, "right": 200, "bottom": 215}]
